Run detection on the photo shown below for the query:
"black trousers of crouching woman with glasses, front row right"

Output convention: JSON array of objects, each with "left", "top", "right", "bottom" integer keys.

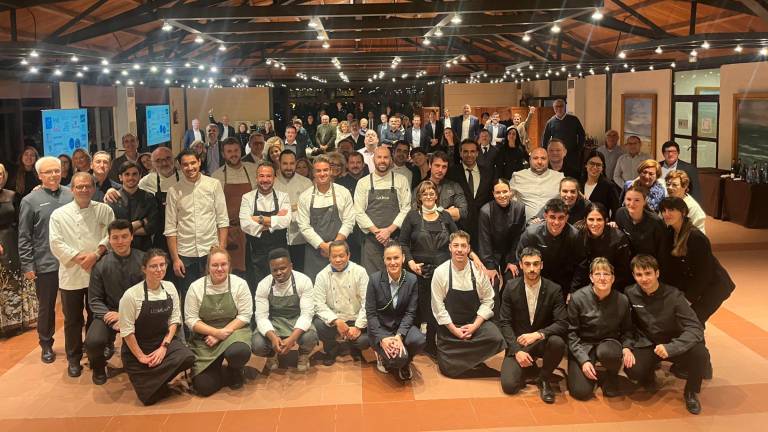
[{"left": 568, "top": 339, "right": 623, "bottom": 400}]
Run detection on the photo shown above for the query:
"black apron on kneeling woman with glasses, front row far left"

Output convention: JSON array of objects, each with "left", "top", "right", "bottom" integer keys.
[{"left": 122, "top": 281, "right": 194, "bottom": 403}]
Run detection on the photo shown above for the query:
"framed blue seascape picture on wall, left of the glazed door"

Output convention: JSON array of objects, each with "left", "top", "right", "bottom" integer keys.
[{"left": 620, "top": 94, "right": 656, "bottom": 158}]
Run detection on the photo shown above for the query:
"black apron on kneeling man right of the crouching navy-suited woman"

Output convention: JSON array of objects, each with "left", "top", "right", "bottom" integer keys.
[{"left": 437, "top": 263, "right": 505, "bottom": 377}]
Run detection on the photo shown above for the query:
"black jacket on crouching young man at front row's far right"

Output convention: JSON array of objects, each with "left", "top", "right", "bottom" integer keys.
[{"left": 624, "top": 283, "right": 704, "bottom": 357}]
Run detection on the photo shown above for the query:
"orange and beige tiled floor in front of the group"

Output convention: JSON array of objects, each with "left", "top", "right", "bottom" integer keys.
[{"left": 0, "top": 219, "right": 768, "bottom": 432}]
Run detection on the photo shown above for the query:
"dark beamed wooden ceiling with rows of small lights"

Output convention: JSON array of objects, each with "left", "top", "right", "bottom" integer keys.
[{"left": 0, "top": 0, "right": 768, "bottom": 86}]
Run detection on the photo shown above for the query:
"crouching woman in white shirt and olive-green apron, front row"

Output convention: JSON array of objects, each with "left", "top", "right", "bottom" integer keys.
[{"left": 184, "top": 246, "right": 253, "bottom": 396}]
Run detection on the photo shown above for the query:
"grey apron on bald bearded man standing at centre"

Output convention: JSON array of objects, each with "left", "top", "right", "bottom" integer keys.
[{"left": 362, "top": 171, "right": 400, "bottom": 274}]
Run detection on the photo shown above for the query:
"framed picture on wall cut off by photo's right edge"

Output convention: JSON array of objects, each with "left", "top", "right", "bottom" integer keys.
[{"left": 733, "top": 93, "right": 768, "bottom": 163}]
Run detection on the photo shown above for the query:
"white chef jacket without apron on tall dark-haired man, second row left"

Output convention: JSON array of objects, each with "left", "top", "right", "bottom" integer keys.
[{"left": 164, "top": 175, "right": 229, "bottom": 257}]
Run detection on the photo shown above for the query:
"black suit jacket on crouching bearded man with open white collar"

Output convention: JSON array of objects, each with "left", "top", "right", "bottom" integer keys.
[{"left": 499, "top": 277, "right": 568, "bottom": 356}]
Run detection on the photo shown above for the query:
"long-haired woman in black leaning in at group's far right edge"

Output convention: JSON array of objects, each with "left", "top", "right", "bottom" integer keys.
[{"left": 660, "top": 197, "right": 736, "bottom": 324}]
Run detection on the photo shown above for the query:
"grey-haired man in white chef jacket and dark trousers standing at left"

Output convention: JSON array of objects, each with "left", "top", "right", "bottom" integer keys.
[{"left": 49, "top": 173, "right": 115, "bottom": 378}]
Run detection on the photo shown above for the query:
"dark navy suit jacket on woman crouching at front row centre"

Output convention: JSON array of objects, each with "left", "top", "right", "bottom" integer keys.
[{"left": 365, "top": 271, "right": 419, "bottom": 345}]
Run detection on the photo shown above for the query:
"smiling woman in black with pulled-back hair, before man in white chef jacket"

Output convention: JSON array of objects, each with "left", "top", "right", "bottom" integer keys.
[{"left": 477, "top": 179, "right": 526, "bottom": 285}]
